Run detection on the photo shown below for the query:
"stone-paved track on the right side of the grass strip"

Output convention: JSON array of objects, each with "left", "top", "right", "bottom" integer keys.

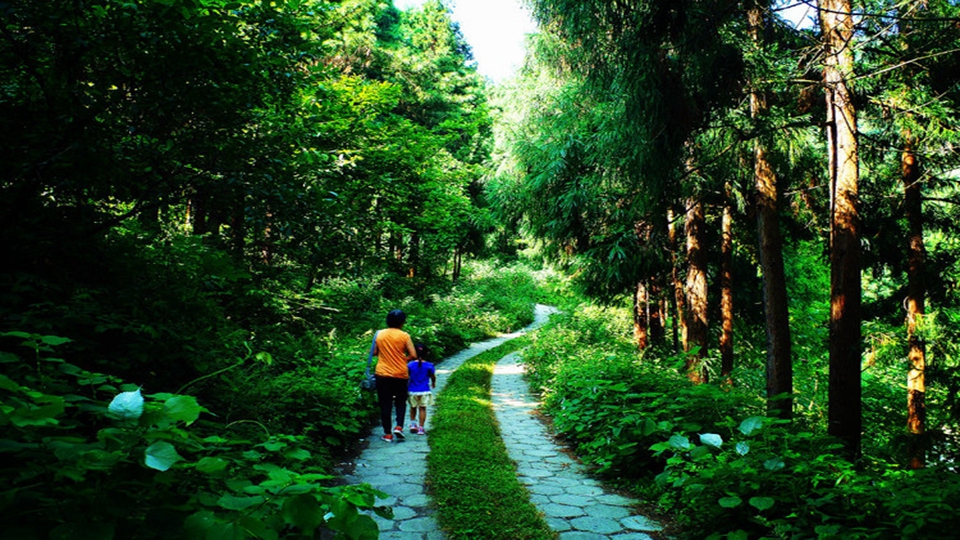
[{"left": 491, "top": 353, "right": 661, "bottom": 540}]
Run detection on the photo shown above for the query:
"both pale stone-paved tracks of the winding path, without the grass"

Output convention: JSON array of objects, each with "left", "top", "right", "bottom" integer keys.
[{"left": 344, "top": 305, "right": 660, "bottom": 540}]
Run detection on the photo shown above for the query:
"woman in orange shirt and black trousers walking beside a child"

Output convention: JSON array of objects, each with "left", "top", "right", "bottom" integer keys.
[{"left": 373, "top": 309, "right": 417, "bottom": 442}]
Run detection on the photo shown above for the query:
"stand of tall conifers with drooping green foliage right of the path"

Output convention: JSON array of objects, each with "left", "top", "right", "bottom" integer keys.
[{"left": 488, "top": 0, "right": 960, "bottom": 464}]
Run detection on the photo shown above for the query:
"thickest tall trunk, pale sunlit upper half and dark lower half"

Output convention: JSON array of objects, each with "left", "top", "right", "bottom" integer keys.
[{"left": 818, "top": 0, "right": 863, "bottom": 458}]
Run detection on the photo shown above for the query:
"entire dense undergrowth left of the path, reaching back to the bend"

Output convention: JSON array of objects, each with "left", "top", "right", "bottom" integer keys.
[{"left": 0, "top": 227, "right": 537, "bottom": 539}]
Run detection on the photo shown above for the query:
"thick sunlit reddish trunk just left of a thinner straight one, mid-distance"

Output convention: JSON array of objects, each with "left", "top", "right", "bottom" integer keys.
[{"left": 683, "top": 198, "right": 708, "bottom": 384}]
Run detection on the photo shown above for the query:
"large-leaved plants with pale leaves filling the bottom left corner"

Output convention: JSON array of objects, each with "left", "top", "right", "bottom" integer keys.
[{"left": 0, "top": 332, "right": 388, "bottom": 539}]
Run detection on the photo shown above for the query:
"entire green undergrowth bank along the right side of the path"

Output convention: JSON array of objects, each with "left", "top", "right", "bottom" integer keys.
[{"left": 524, "top": 303, "right": 960, "bottom": 539}]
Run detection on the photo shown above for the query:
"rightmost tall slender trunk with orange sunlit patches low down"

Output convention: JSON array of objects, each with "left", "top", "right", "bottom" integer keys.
[{"left": 901, "top": 134, "right": 927, "bottom": 469}]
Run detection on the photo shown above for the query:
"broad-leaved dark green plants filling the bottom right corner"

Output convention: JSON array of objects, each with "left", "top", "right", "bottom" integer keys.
[{"left": 651, "top": 417, "right": 960, "bottom": 538}]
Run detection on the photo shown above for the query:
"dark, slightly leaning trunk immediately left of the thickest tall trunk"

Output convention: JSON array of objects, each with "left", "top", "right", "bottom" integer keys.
[{"left": 747, "top": 4, "right": 793, "bottom": 419}]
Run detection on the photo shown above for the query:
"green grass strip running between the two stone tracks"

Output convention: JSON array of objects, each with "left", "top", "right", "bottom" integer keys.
[{"left": 427, "top": 336, "right": 557, "bottom": 540}]
